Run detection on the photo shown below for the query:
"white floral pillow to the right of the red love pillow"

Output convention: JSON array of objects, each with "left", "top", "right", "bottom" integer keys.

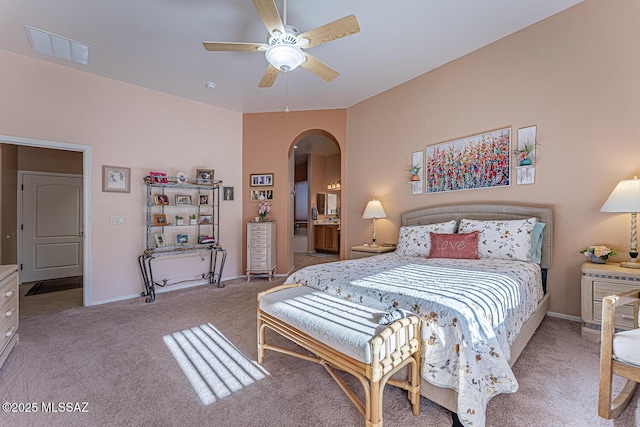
[{"left": 458, "top": 218, "right": 536, "bottom": 261}]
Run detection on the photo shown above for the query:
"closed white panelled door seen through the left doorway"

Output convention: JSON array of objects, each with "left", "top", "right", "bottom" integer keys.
[{"left": 20, "top": 173, "right": 83, "bottom": 283}]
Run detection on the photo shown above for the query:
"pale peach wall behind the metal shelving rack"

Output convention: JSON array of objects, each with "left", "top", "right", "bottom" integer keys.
[{"left": 0, "top": 51, "right": 243, "bottom": 303}]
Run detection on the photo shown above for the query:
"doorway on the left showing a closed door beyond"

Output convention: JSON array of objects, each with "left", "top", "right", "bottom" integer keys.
[{"left": 0, "top": 136, "right": 90, "bottom": 318}]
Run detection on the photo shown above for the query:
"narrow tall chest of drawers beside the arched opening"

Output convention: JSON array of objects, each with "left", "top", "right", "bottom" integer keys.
[{"left": 247, "top": 222, "right": 277, "bottom": 282}]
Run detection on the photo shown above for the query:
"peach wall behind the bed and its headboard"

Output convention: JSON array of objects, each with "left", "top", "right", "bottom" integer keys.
[{"left": 343, "top": 0, "right": 640, "bottom": 316}]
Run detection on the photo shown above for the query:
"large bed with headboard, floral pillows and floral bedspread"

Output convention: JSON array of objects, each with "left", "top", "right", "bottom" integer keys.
[{"left": 285, "top": 204, "right": 553, "bottom": 427}]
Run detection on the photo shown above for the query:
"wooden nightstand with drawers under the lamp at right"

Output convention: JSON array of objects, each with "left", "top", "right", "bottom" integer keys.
[{"left": 581, "top": 262, "right": 640, "bottom": 342}]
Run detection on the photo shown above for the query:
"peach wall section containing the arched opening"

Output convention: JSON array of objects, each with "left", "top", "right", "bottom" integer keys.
[{"left": 242, "top": 110, "right": 347, "bottom": 274}]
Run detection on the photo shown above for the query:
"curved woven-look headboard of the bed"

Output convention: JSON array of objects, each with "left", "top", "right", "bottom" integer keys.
[{"left": 401, "top": 203, "right": 553, "bottom": 270}]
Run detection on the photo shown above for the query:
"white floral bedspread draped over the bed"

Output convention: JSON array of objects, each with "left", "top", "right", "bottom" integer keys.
[{"left": 285, "top": 254, "right": 544, "bottom": 427}]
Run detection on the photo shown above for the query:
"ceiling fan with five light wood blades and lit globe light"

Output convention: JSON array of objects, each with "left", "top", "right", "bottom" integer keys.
[{"left": 202, "top": 0, "right": 360, "bottom": 87}]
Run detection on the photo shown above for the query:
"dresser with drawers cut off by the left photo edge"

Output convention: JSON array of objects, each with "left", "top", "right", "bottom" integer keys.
[{"left": 0, "top": 265, "right": 18, "bottom": 368}]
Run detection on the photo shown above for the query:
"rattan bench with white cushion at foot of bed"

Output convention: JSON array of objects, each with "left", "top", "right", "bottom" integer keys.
[{"left": 258, "top": 284, "right": 420, "bottom": 427}]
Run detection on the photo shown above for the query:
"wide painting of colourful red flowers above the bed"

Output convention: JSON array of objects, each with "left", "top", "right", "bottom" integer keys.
[{"left": 425, "top": 128, "right": 511, "bottom": 194}]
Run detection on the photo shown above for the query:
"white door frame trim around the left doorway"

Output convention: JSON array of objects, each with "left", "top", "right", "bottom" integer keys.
[{"left": 0, "top": 135, "right": 91, "bottom": 307}]
